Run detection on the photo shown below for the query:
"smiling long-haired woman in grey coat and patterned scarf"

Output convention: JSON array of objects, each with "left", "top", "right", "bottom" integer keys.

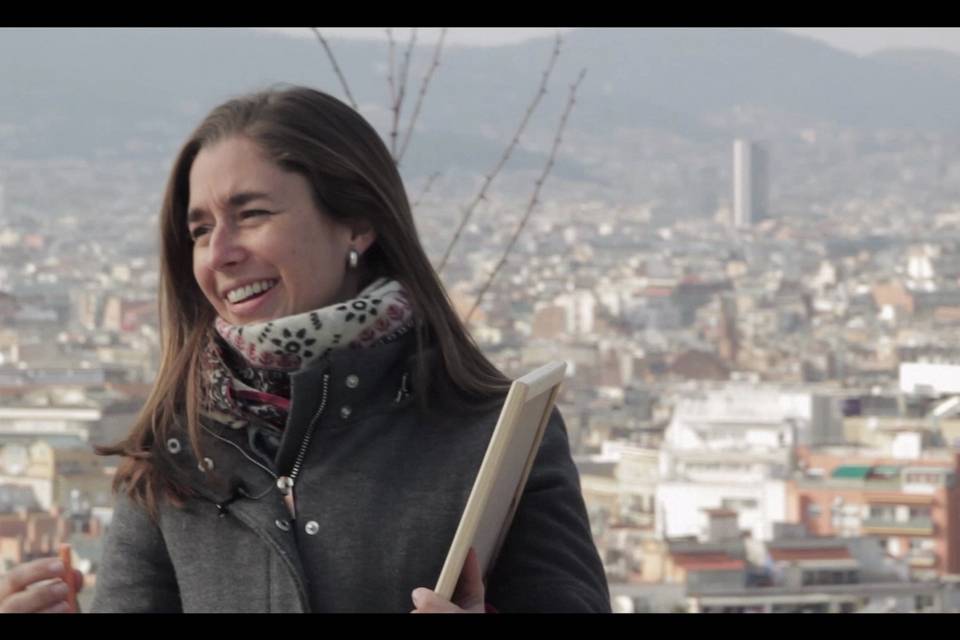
[{"left": 0, "top": 88, "right": 609, "bottom": 612}]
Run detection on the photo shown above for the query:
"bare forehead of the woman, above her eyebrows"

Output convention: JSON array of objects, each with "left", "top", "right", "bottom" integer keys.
[{"left": 188, "top": 137, "right": 290, "bottom": 209}]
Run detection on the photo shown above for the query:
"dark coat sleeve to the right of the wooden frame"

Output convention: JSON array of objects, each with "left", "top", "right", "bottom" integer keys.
[{"left": 486, "top": 409, "right": 610, "bottom": 613}]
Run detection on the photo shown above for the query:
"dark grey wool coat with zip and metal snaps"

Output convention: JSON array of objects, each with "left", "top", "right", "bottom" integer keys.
[{"left": 92, "top": 332, "right": 610, "bottom": 612}]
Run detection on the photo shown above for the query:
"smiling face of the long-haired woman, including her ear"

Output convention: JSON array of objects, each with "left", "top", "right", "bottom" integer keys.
[{"left": 187, "top": 136, "right": 374, "bottom": 325}]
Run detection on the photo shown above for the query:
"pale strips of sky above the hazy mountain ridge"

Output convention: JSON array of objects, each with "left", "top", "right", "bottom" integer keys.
[{"left": 256, "top": 27, "right": 960, "bottom": 55}]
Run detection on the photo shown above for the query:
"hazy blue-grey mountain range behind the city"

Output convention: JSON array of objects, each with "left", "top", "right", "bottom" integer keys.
[{"left": 0, "top": 28, "right": 960, "bottom": 173}]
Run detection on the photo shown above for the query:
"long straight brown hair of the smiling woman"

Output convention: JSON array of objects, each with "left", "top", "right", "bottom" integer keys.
[{"left": 97, "top": 87, "right": 509, "bottom": 517}]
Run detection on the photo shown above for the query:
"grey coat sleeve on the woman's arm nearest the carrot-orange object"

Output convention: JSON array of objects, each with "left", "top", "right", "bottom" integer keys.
[{"left": 91, "top": 492, "right": 182, "bottom": 613}]
